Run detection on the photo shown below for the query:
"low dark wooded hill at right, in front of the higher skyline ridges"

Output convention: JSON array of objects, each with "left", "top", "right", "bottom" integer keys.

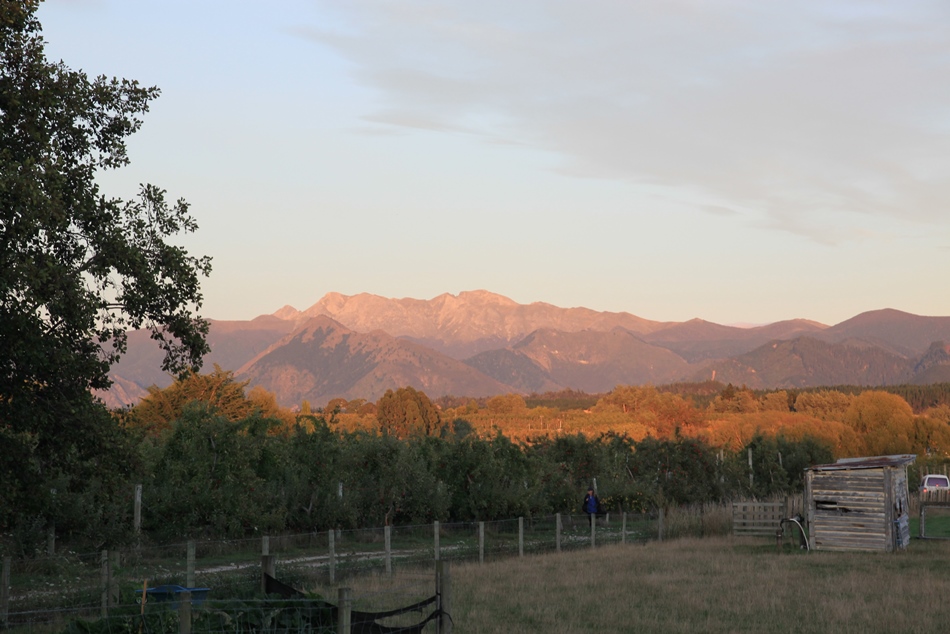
[{"left": 692, "top": 337, "right": 914, "bottom": 388}]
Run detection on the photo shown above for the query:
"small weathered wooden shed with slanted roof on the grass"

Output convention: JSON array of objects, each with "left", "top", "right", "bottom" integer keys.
[{"left": 805, "top": 454, "right": 917, "bottom": 552}]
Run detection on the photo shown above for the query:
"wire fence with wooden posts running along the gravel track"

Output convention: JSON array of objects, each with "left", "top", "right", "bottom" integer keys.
[{"left": 0, "top": 507, "right": 716, "bottom": 634}]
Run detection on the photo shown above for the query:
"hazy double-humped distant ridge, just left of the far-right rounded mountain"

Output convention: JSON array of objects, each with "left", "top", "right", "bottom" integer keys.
[{"left": 643, "top": 319, "right": 827, "bottom": 363}]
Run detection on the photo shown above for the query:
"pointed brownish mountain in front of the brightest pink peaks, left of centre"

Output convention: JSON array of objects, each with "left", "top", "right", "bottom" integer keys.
[{"left": 238, "top": 316, "right": 512, "bottom": 406}]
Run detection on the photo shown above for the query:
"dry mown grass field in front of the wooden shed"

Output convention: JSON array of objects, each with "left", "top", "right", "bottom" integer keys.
[{"left": 344, "top": 537, "right": 950, "bottom": 634}]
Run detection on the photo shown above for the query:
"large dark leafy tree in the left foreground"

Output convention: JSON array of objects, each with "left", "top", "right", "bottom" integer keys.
[{"left": 0, "top": 0, "right": 210, "bottom": 540}]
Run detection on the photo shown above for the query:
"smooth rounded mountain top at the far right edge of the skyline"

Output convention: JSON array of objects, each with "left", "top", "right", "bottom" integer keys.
[{"left": 818, "top": 308, "right": 950, "bottom": 356}]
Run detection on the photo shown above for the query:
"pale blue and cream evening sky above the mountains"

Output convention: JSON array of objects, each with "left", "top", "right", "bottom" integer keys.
[{"left": 38, "top": 0, "right": 950, "bottom": 325}]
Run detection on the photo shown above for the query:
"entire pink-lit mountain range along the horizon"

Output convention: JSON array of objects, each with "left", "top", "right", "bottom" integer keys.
[{"left": 102, "top": 291, "right": 950, "bottom": 407}]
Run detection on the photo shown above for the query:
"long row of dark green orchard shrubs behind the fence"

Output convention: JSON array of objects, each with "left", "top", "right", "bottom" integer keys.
[{"left": 4, "top": 403, "right": 832, "bottom": 556}]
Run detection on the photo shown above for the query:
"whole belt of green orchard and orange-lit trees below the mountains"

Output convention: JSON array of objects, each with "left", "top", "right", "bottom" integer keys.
[{"left": 13, "top": 358, "right": 950, "bottom": 555}]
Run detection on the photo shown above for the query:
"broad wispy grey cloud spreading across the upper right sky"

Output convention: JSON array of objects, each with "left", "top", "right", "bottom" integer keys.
[{"left": 302, "top": 0, "right": 950, "bottom": 241}]
